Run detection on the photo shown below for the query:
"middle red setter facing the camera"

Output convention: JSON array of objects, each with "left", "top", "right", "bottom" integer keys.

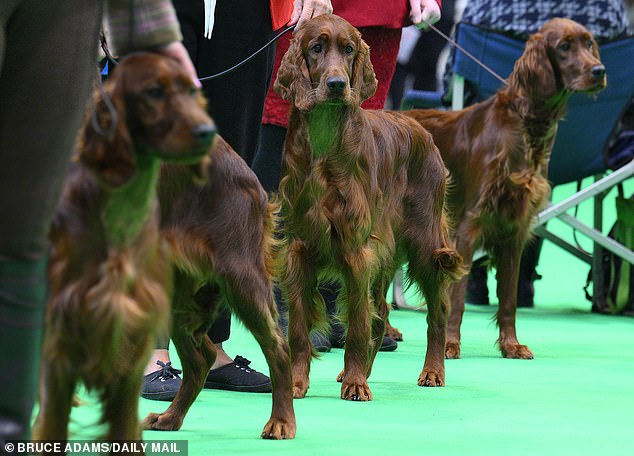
[{"left": 275, "top": 15, "right": 463, "bottom": 401}]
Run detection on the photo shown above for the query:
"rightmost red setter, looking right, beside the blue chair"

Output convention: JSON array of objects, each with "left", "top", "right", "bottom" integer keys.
[{"left": 406, "top": 19, "right": 606, "bottom": 359}]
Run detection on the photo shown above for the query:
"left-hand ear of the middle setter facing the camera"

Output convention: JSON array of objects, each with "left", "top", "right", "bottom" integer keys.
[{"left": 273, "top": 30, "right": 313, "bottom": 111}]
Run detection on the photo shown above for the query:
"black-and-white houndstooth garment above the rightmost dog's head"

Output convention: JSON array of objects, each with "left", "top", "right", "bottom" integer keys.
[{"left": 462, "top": 0, "right": 629, "bottom": 41}]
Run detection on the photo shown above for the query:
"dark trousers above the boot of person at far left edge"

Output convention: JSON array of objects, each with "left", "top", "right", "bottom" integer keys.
[{"left": 0, "top": 0, "right": 101, "bottom": 261}]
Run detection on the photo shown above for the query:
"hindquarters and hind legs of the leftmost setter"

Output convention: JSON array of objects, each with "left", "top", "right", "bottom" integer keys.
[{"left": 144, "top": 137, "right": 296, "bottom": 439}]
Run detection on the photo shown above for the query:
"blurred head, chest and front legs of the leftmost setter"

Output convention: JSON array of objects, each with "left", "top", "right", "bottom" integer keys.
[{"left": 34, "top": 54, "right": 215, "bottom": 440}]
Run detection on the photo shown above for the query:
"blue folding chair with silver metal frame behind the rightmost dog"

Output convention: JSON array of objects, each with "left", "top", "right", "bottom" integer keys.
[{"left": 393, "top": 22, "right": 634, "bottom": 308}]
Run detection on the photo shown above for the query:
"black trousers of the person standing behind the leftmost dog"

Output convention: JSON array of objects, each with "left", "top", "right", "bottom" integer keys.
[{"left": 173, "top": 0, "right": 275, "bottom": 343}]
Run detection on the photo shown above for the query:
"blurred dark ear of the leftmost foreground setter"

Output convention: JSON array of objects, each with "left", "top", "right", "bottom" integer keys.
[{"left": 76, "top": 75, "right": 136, "bottom": 188}]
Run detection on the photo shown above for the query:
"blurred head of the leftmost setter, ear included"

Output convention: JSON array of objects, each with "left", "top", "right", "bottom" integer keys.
[{"left": 78, "top": 53, "right": 216, "bottom": 187}]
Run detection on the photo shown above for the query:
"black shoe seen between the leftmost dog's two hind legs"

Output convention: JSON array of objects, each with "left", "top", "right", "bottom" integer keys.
[{"left": 205, "top": 355, "right": 272, "bottom": 393}]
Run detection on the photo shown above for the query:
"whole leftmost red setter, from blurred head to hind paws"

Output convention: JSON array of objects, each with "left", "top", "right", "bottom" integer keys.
[{"left": 37, "top": 55, "right": 295, "bottom": 440}]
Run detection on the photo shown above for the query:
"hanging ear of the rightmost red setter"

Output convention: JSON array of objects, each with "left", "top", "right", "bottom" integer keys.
[{"left": 509, "top": 33, "right": 557, "bottom": 99}]
